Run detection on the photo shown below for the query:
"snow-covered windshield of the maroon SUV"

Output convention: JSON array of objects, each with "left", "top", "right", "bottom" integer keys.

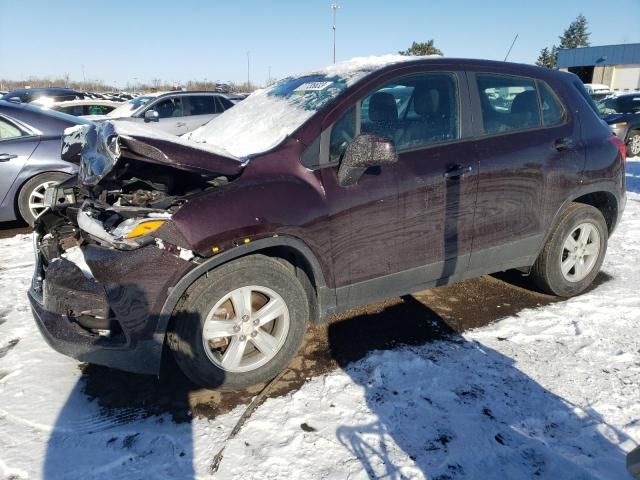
[{"left": 184, "top": 55, "right": 420, "bottom": 158}]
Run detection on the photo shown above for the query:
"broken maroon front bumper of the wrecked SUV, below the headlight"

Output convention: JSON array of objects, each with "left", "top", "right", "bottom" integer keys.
[{"left": 29, "top": 234, "right": 193, "bottom": 374}]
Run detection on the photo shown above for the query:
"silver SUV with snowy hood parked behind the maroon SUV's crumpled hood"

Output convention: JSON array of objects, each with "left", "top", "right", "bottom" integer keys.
[{"left": 86, "top": 91, "right": 242, "bottom": 135}]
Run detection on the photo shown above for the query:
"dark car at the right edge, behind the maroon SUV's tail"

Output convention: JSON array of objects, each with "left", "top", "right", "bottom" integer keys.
[{"left": 598, "top": 92, "right": 640, "bottom": 157}]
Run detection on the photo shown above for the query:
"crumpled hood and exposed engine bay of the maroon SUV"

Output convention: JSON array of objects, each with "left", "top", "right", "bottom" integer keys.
[{"left": 36, "top": 122, "right": 243, "bottom": 261}]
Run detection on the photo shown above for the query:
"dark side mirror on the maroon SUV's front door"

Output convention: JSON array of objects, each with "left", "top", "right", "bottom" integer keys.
[{"left": 338, "top": 134, "right": 398, "bottom": 187}]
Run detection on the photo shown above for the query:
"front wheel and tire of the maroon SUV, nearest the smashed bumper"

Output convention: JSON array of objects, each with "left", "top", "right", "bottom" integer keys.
[{"left": 167, "top": 255, "right": 309, "bottom": 390}]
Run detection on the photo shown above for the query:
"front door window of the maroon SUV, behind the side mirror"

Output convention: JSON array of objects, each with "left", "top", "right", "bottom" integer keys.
[{"left": 329, "top": 73, "right": 459, "bottom": 162}]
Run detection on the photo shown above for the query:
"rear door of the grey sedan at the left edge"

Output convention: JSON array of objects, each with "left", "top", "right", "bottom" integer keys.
[{"left": 0, "top": 115, "right": 39, "bottom": 206}]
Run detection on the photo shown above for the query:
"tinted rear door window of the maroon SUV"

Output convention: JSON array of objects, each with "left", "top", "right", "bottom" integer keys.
[{"left": 476, "top": 74, "right": 541, "bottom": 134}]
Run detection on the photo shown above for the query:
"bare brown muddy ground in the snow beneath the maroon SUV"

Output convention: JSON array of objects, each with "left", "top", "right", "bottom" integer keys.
[{"left": 74, "top": 272, "right": 596, "bottom": 422}]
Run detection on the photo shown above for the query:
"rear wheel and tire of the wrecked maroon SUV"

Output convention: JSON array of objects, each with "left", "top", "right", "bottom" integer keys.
[{"left": 531, "top": 203, "right": 609, "bottom": 297}]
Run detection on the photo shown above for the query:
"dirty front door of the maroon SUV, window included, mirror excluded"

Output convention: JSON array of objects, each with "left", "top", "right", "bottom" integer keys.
[{"left": 320, "top": 72, "right": 477, "bottom": 307}]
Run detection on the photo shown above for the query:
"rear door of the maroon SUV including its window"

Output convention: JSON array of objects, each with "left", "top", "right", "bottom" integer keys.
[{"left": 469, "top": 72, "right": 583, "bottom": 271}]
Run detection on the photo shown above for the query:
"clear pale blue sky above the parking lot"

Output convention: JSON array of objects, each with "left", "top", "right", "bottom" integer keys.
[{"left": 0, "top": 0, "right": 640, "bottom": 87}]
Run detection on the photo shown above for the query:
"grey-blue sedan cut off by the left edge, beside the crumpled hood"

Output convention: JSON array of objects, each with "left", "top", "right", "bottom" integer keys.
[{"left": 0, "top": 100, "right": 89, "bottom": 224}]
